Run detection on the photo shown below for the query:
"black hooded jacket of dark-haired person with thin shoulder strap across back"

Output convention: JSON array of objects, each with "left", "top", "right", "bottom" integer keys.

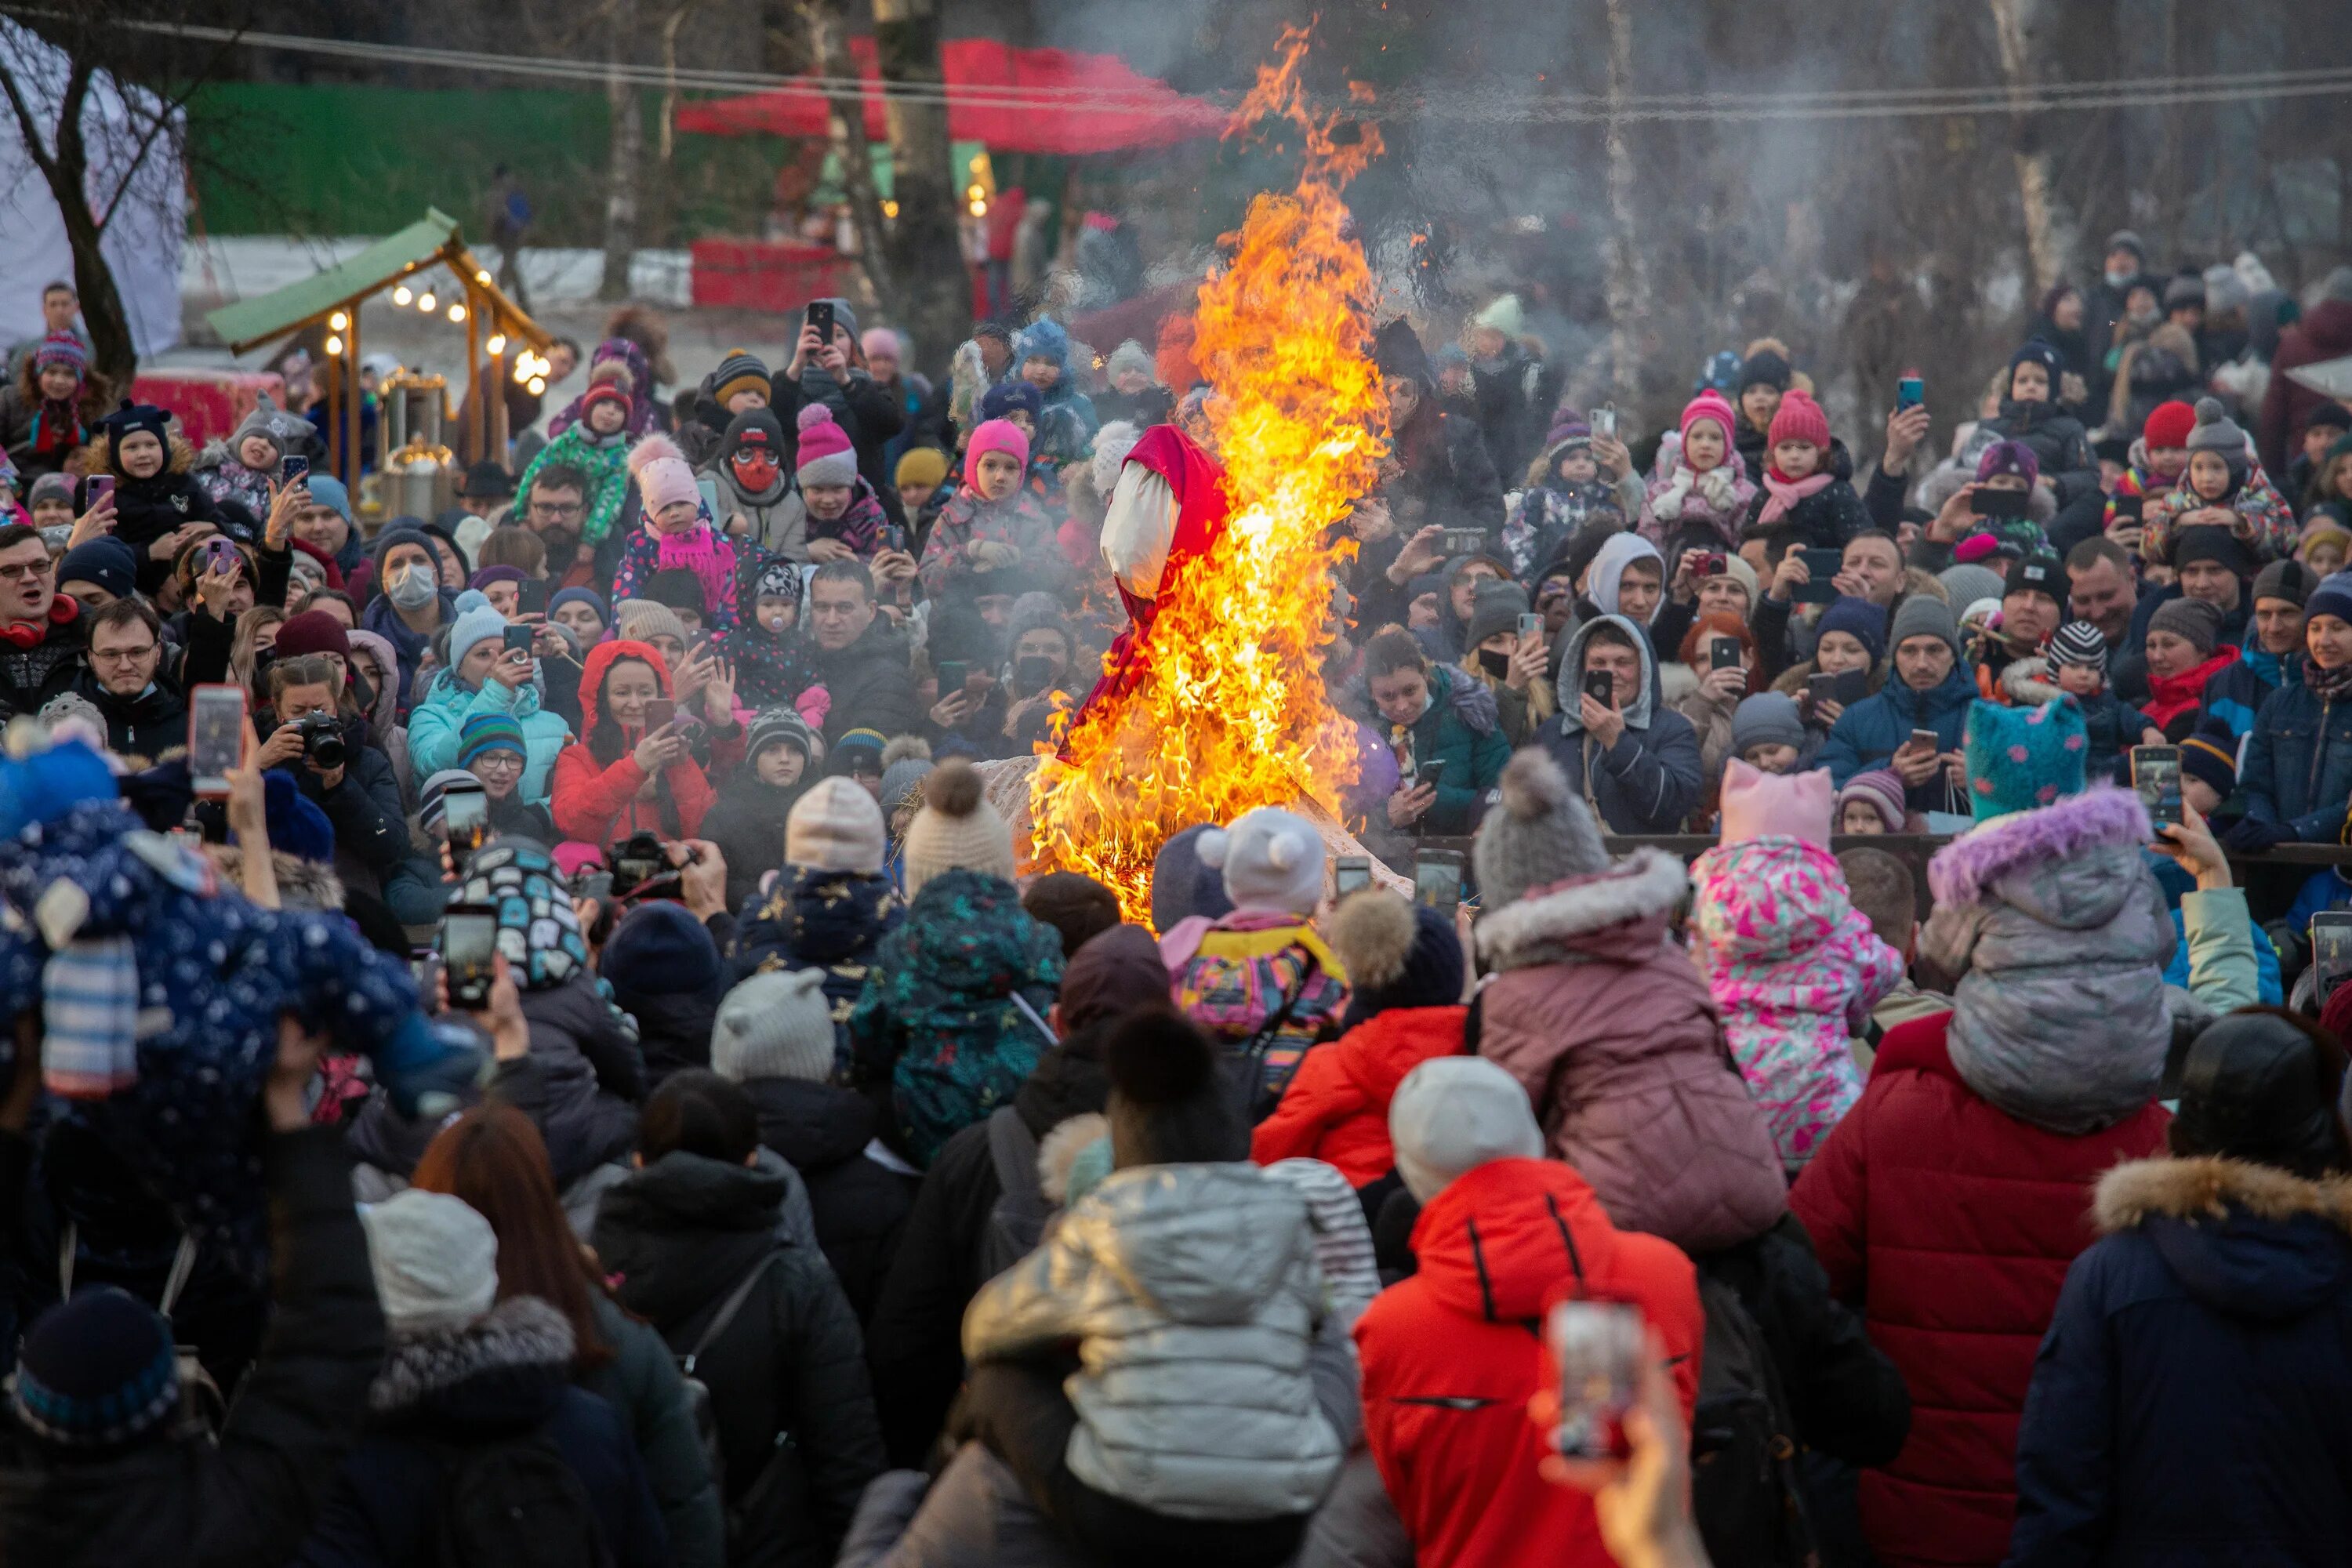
[{"left": 595, "top": 1152, "right": 882, "bottom": 1568}]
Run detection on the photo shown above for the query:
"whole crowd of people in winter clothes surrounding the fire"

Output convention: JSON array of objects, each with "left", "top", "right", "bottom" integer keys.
[{"left": 0, "top": 233, "right": 2352, "bottom": 1568}]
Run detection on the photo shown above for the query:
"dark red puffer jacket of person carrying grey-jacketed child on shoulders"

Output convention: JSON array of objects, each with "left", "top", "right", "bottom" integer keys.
[{"left": 1790, "top": 1013, "right": 2169, "bottom": 1568}]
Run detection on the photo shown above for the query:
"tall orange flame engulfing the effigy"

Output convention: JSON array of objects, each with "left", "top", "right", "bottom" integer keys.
[{"left": 1030, "top": 28, "right": 1388, "bottom": 919}]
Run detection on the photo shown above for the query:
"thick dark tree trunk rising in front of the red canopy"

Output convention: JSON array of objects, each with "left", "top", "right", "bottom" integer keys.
[{"left": 875, "top": 0, "right": 971, "bottom": 374}]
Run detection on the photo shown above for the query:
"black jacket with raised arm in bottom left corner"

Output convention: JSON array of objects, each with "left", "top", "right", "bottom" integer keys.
[{"left": 0, "top": 1126, "right": 383, "bottom": 1568}]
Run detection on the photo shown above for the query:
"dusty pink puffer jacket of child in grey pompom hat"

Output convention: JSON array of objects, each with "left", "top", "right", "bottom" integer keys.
[{"left": 1477, "top": 848, "right": 1788, "bottom": 1255}]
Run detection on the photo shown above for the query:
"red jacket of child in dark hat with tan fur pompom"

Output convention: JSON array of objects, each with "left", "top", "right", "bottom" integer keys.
[{"left": 1249, "top": 1006, "right": 1470, "bottom": 1187}]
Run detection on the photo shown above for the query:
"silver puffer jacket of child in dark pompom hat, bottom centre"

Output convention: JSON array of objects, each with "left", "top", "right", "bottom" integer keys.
[{"left": 964, "top": 1163, "right": 1341, "bottom": 1519}]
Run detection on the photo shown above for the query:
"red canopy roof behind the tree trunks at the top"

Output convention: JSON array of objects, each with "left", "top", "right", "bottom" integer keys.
[{"left": 677, "top": 38, "right": 1228, "bottom": 155}]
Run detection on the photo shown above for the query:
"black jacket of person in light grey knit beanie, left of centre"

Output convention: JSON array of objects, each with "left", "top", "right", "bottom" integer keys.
[{"left": 743, "top": 1079, "right": 915, "bottom": 1323}]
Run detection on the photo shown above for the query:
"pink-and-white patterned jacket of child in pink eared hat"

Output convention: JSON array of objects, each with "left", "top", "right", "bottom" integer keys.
[{"left": 1691, "top": 834, "right": 1903, "bottom": 1171}]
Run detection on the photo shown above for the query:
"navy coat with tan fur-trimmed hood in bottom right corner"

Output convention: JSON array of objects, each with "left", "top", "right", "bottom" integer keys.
[{"left": 2009, "top": 1159, "right": 2352, "bottom": 1568}]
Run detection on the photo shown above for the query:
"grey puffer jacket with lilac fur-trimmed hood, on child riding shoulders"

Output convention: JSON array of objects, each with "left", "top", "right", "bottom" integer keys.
[{"left": 1919, "top": 787, "right": 2176, "bottom": 1135}]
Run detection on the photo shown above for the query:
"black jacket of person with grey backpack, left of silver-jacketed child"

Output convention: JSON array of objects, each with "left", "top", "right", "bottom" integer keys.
[{"left": 866, "top": 1027, "right": 1110, "bottom": 1467}]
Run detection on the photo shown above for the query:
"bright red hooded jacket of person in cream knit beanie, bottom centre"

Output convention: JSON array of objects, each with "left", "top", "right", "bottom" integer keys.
[{"left": 1355, "top": 1161, "right": 1705, "bottom": 1568}]
